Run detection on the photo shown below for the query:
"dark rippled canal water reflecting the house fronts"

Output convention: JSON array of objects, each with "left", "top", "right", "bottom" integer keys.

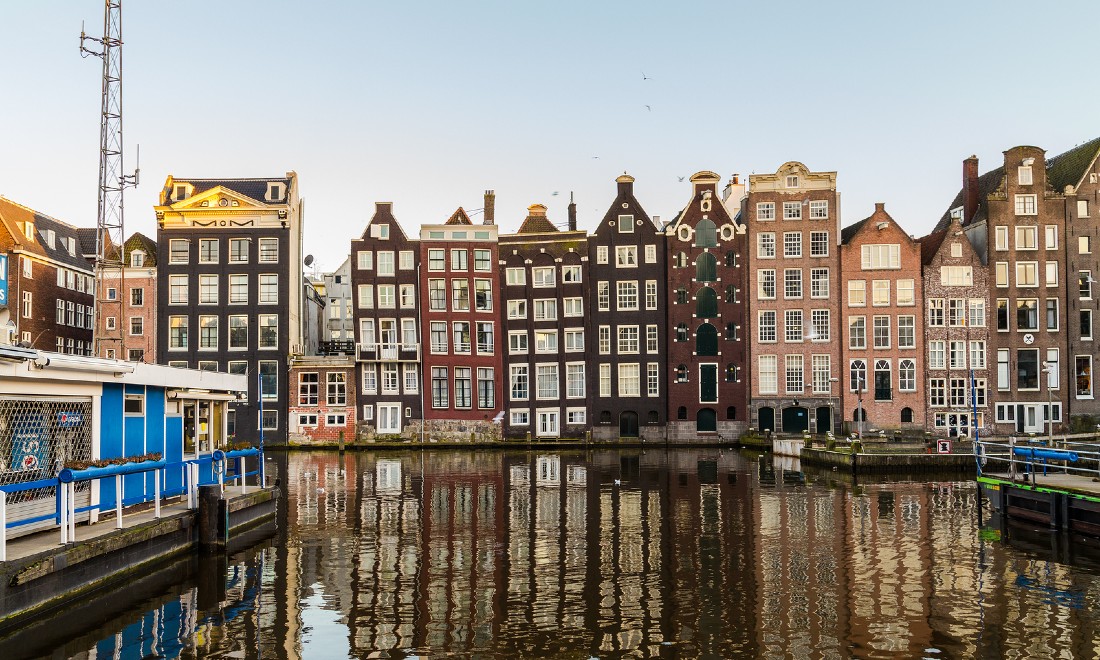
[{"left": 0, "top": 449, "right": 1100, "bottom": 659}]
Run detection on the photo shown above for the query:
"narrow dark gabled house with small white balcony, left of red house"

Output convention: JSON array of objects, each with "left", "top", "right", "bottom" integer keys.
[{"left": 352, "top": 201, "right": 424, "bottom": 436}]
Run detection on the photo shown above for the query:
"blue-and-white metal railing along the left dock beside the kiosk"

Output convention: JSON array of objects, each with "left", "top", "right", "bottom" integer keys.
[{"left": 0, "top": 449, "right": 266, "bottom": 561}]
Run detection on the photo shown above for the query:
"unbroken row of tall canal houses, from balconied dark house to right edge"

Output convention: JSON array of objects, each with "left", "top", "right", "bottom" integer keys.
[{"left": 341, "top": 136, "right": 1100, "bottom": 440}]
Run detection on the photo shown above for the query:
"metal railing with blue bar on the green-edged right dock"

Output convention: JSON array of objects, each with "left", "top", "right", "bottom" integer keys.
[{"left": 974, "top": 436, "right": 1100, "bottom": 484}]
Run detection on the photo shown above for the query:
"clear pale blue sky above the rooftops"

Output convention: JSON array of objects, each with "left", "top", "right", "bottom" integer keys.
[{"left": 0, "top": 0, "right": 1100, "bottom": 272}]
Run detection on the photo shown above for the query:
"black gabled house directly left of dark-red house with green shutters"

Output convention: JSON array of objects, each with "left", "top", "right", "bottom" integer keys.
[{"left": 585, "top": 174, "right": 668, "bottom": 441}]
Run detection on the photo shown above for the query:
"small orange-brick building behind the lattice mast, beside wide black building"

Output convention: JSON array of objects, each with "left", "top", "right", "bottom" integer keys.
[{"left": 92, "top": 232, "right": 157, "bottom": 364}]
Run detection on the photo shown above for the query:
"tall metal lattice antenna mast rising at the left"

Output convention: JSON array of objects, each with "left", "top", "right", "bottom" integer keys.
[{"left": 80, "top": 0, "right": 140, "bottom": 360}]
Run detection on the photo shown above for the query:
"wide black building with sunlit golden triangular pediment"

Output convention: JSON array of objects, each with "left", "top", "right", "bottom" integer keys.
[{"left": 154, "top": 172, "right": 307, "bottom": 442}]
